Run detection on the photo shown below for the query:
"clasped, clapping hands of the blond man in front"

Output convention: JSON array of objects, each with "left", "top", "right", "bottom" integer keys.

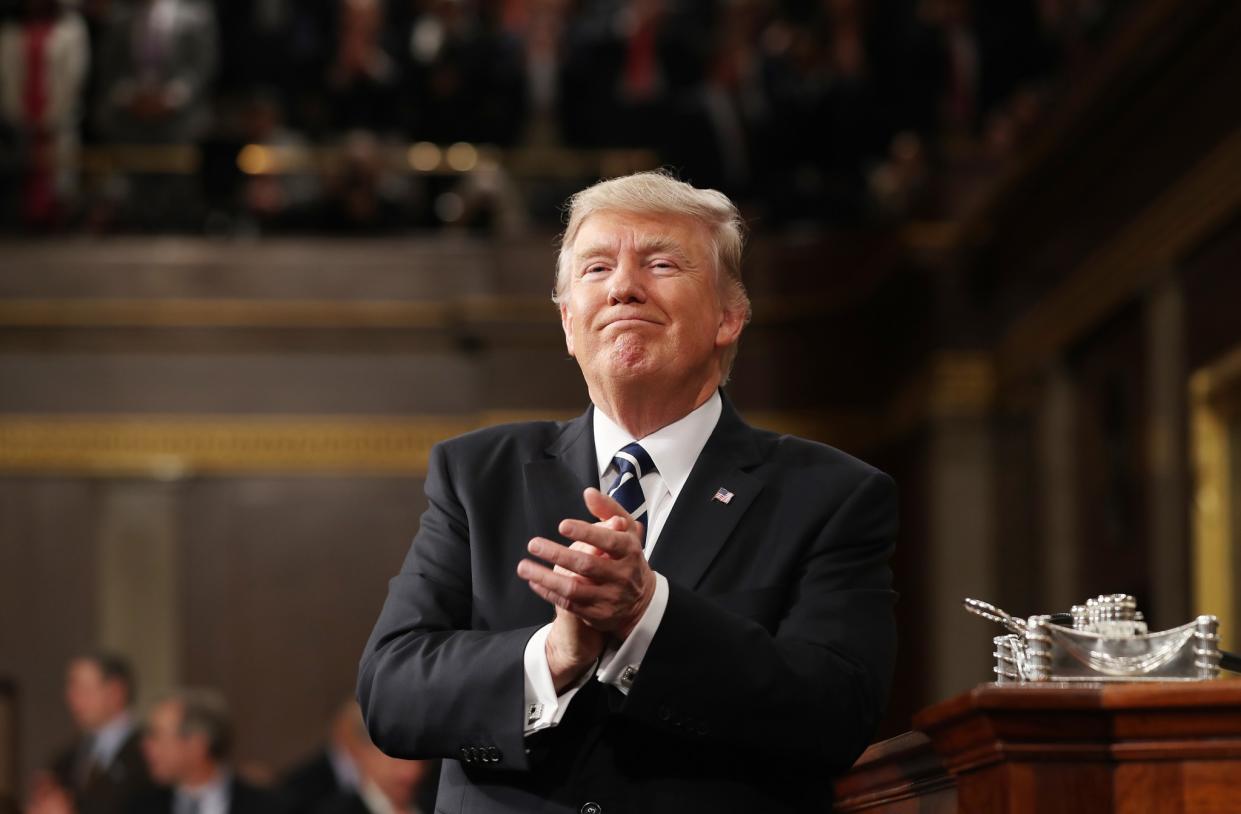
[{"left": 517, "top": 488, "right": 655, "bottom": 694}]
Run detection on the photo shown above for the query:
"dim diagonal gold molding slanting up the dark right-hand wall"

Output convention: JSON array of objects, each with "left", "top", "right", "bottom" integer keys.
[{"left": 998, "top": 130, "right": 1241, "bottom": 382}]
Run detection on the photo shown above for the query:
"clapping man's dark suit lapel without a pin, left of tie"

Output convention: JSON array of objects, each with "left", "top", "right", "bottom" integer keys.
[{"left": 522, "top": 409, "right": 599, "bottom": 540}]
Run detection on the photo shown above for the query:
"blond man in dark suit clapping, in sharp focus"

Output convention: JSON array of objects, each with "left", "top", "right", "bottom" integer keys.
[{"left": 359, "top": 172, "right": 896, "bottom": 814}]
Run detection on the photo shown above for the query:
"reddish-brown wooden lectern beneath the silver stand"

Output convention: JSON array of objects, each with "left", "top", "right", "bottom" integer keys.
[{"left": 835, "top": 680, "right": 1241, "bottom": 814}]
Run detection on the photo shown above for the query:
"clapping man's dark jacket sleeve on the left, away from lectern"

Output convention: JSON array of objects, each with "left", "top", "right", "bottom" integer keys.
[{"left": 357, "top": 444, "right": 537, "bottom": 769}]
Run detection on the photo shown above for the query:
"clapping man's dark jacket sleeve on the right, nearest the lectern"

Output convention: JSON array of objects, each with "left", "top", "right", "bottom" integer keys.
[{"left": 622, "top": 470, "right": 897, "bottom": 772}]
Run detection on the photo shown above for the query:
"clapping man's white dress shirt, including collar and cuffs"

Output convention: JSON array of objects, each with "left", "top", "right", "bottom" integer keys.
[{"left": 524, "top": 391, "right": 724, "bottom": 735}]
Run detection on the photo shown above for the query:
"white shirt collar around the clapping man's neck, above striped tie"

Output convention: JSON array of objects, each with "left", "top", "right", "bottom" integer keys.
[{"left": 593, "top": 390, "right": 724, "bottom": 500}]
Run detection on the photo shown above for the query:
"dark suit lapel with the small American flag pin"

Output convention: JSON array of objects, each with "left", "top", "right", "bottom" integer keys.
[{"left": 650, "top": 392, "right": 763, "bottom": 588}]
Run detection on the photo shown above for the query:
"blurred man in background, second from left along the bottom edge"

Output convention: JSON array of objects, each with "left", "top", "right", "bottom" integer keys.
[{"left": 130, "top": 689, "right": 282, "bottom": 814}]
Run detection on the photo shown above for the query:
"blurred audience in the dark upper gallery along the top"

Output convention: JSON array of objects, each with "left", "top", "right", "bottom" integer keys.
[{"left": 0, "top": 0, "right": 1131, "bottom": 233}]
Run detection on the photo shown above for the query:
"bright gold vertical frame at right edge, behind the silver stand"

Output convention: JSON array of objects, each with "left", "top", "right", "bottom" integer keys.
[{"left": 1189, "top": 350, "right": 1241, "bottom": 650}]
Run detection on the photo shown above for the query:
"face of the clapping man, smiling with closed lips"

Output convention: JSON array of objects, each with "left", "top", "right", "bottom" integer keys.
[{"left": 560, "top": 211, "right": 742, "bottom": 385}]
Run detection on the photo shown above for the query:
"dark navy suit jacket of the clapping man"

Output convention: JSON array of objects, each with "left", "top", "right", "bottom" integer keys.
[{"left": 357, "top": 398, "right": 896, "bottom": 814}]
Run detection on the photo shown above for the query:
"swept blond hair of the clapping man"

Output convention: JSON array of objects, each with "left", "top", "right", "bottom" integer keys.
[{"left": 551, "top": 170, "right": 751, "bottom": 383}]
